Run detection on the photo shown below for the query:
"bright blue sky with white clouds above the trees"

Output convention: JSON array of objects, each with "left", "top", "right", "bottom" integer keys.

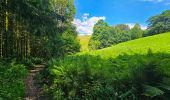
[{"left": 73, "top": 0, "right": 170, "bottom": 35}]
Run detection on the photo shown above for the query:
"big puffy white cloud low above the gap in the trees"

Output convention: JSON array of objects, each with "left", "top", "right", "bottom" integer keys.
[{"left": 72, "top": 13, "right": 106, "bottom": 35}]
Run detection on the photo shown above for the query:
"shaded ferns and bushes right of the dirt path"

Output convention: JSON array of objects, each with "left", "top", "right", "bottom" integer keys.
[{"left": 41, "top": 52, "right": 170, "bottom": 100}]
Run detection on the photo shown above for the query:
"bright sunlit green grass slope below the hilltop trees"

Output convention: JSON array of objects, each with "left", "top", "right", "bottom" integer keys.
[{"left": 80, "top": 32, "right": 170, "bottom": 58}]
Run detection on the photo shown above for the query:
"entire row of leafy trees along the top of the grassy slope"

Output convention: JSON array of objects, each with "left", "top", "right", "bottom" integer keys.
[{"left": 89, "top": 10, "right": 170, "bottom": 50}]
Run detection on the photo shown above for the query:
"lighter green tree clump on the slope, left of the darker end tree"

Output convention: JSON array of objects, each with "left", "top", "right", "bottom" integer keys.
[{"left": 89, "top": 20, "right": 143, "bottom": 50}]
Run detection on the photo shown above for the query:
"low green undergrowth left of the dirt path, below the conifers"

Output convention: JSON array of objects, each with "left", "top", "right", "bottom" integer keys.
[{"left": 0, "top": 60, "right": 27, "bottom": 100}]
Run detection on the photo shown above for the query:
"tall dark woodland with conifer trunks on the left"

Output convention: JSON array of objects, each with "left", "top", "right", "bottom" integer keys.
[{"left": 0, "top": 0, "right": 80, "bottom": 58}]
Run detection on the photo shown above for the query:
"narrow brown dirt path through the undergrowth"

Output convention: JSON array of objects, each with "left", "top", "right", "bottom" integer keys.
[{"left": 24, "top": 64, "right": 45, "bottom": 100}]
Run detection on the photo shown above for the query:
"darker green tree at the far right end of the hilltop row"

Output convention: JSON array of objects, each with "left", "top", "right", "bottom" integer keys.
[{"left": 147, "top": 10, "right": 170, "bottom": 35}]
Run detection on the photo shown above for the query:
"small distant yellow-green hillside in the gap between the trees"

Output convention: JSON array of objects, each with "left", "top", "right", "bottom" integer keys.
[{"left": 78, "top": 36, "right": 91, "bottom": 51}]
